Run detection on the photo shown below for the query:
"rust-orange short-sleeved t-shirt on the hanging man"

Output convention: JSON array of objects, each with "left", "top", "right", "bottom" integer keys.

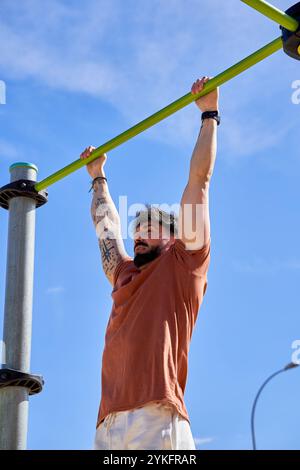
[{"left": 97, "top": 239, "right": 210, "bottom": 427}]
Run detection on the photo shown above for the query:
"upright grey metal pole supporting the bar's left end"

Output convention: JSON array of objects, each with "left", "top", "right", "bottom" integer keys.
[{"left": 0, "top": 162, "right": 38, "bottom": 450}]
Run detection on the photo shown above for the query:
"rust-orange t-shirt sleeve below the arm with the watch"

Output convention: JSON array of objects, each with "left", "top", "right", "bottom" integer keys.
[{"left": 174, "top": 238, "right": 210, "bottom": 276}]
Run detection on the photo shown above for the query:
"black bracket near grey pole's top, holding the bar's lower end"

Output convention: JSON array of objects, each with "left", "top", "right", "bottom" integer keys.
[{"left": 0, "top": 179, "right": 48, "bottom": 209}]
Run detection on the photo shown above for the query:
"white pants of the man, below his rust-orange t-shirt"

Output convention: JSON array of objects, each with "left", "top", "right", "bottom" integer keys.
[{"left": 94, "top": 402, "right": 196, "bottom": 450}]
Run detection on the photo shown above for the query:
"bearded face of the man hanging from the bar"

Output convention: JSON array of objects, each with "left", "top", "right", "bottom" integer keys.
[{"left": 133, "top": 221, "right": 173, "bottom": 267}]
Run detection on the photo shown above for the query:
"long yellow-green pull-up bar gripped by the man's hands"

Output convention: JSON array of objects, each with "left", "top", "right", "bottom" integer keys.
[{"left": 35, "top": 37, "right": 282, "bottom": 191}]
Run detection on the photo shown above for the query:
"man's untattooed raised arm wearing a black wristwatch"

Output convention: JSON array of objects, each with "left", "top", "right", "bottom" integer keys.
[{"left": 179, "top": 77, "right": 218, "bottom": 250}]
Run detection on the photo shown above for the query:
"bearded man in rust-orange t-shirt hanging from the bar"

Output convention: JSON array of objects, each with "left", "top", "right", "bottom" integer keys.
[{"left": 81, "top": 77, "right": 219, "bottom": 450}]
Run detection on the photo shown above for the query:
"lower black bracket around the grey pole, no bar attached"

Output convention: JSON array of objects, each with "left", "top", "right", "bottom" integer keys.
[{"left": 0, "top": 368, "right": 44, "bottom": 395}]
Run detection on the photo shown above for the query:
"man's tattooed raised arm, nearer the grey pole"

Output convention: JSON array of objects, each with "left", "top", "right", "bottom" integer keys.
[{"left": 80, "top": 147, "right": 129, "bottom": 285}]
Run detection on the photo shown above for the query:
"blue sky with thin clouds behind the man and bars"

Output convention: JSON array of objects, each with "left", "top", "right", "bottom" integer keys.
[{"left": 0, "top": 0, "right": 300, "bottom": 449}]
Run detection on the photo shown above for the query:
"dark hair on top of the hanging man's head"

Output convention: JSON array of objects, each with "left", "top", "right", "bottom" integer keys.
[{"left": 134, "top": 204, "right": 178, "bottom": 235}]
